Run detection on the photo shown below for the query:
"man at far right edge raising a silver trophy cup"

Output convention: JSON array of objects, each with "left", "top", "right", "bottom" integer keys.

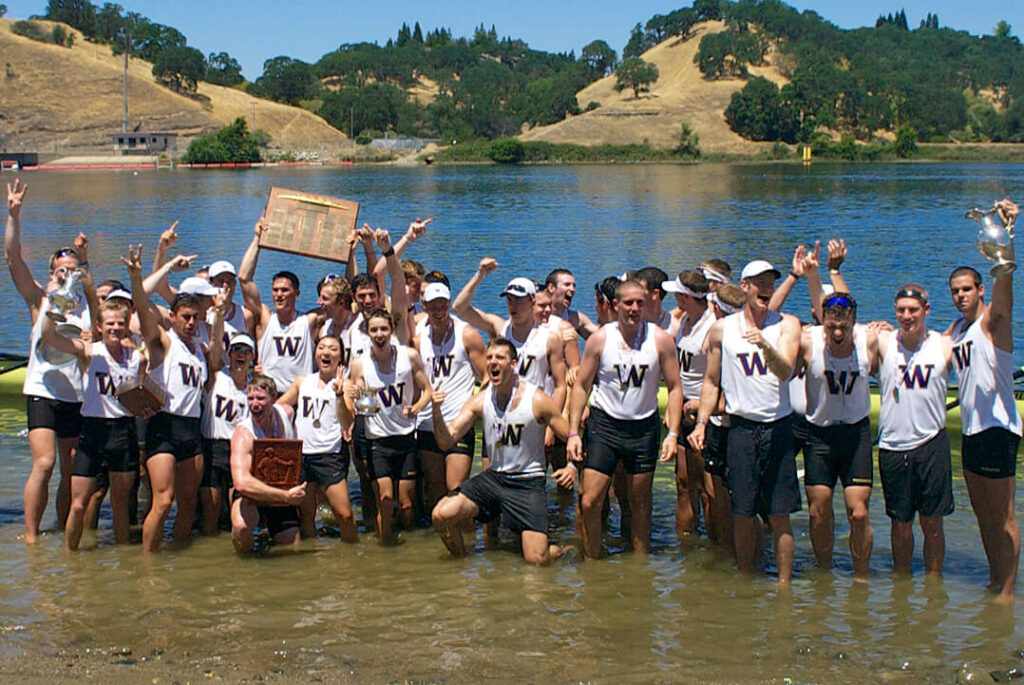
[{"left": 947, "top": 200, "right": 1021, "bottom": 603}]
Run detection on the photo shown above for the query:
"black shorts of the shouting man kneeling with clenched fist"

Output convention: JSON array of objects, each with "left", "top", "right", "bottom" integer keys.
[{"left": 456, "top": 471, "right": 548, "bottom": 534}]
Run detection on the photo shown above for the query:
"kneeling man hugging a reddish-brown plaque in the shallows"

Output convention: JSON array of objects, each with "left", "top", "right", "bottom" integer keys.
[{"left": 231, "top": 375, "right": 306, "bottom": 553}]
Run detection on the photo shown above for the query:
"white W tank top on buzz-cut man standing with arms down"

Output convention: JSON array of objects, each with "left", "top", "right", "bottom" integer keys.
[{"left": 591, "top": 322, "right": 662, "bottom": 421}]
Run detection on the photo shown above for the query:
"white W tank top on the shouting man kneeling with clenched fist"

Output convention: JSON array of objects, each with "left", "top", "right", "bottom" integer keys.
[{"left": 483, "top": 380, "right": 547, "bottom": 478}]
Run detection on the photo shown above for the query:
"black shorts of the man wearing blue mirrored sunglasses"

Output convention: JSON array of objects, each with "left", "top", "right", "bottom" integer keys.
[{"left": 804, "top": 417, "right": 874, "bottom": 488}]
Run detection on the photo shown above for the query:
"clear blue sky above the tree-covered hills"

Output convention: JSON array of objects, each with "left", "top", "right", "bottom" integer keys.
[{"left": 0, "top": 0, "right": 1024, "bottom": 79}]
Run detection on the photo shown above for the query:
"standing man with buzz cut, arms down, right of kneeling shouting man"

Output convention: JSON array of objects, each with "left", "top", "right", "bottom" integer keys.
[{"left": 566, "top": 280, "right": 683, "bottom": 559}]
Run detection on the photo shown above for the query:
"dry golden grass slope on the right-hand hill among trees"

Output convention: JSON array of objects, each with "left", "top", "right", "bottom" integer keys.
[{"left": 520, "top": 22, "right": 785, "bottom": 155}]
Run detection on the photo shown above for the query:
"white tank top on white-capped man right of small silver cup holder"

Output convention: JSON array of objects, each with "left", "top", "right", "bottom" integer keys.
[{"left": 417, "top": 319, "right": 476, "bottom": 431}]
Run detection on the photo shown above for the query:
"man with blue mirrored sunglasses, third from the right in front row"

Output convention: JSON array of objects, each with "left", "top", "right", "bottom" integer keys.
[{"left": 800, "top": 293, "right": 879, "bottom": 583}]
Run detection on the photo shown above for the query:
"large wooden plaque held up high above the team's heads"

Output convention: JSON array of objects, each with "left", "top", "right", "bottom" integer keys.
[{"left": 259, "top": 186, "right": 359, "bottom": 262}]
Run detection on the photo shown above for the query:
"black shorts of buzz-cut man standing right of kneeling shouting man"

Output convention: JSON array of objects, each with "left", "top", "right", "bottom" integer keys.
[{"left": 583, "top": 406, "right": 662, "bottom": 476}]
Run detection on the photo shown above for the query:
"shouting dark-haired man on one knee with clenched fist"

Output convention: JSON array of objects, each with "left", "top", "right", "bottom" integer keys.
[{"left": 432, "top": 338, "right": 575, "bottom": 564}]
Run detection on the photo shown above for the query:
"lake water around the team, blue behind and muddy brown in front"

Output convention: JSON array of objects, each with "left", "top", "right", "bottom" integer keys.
[{"left": 0, "top": 164, "right": 1024, "bottom": 683}]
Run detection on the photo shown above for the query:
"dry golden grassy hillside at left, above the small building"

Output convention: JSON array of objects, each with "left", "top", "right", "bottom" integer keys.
[{"left": 0, "top": 19, "right": 350, "bottom": 159}]
